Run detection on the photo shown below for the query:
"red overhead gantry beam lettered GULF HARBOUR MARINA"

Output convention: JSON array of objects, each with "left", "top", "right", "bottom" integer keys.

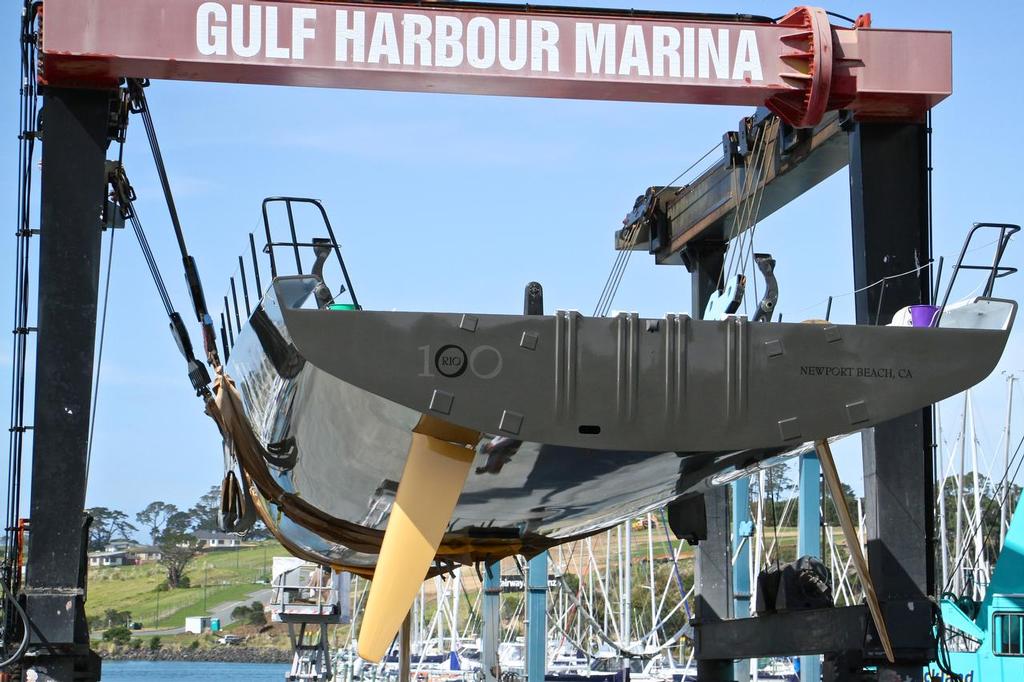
[{"left": 41, "top": 0, "right": 952, "bottom": 126}]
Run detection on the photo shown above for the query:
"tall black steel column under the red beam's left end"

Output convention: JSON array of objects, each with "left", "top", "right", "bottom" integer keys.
[{"left": 25, "top": 89, "right": 111, "bottom": 682}]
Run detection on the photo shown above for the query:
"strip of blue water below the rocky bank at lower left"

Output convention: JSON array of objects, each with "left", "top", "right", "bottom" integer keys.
[{"left": 103, "top": 660, "right": 289, "bottom": 682}]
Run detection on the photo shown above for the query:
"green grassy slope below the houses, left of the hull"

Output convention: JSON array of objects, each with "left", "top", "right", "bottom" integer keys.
[{"left": 85, "top": 541, "right": 280, "bottom": 629}]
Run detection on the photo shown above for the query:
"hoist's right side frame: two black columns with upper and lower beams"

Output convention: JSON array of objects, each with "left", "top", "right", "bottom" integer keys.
[{"left": 615, "top": 100, "right": 935, "bottom": 681}]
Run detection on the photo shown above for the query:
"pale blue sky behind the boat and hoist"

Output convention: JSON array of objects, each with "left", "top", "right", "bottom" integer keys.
[{"left": 0, "top": 0, "right": 1024, "bottom": 513}]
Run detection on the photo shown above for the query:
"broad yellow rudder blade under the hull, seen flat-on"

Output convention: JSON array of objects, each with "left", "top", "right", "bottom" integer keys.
[{"left": 358, "top": 432, "right": 475, "bottom": 662}]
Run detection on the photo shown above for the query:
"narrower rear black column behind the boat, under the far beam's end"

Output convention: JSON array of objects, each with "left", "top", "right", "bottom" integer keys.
[{"left": 684, "top": 242, "right": 734, "bottom": 682}]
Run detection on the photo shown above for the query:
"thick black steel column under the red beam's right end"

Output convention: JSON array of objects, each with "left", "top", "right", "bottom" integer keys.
[{"left": 850, "top": 123, "right": 935, "bottom": 682}]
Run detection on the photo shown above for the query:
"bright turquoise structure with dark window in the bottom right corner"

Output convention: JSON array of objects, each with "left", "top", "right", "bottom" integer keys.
[{"left": 928, "top": 493, "right": 1024, "bottom": 682}]
